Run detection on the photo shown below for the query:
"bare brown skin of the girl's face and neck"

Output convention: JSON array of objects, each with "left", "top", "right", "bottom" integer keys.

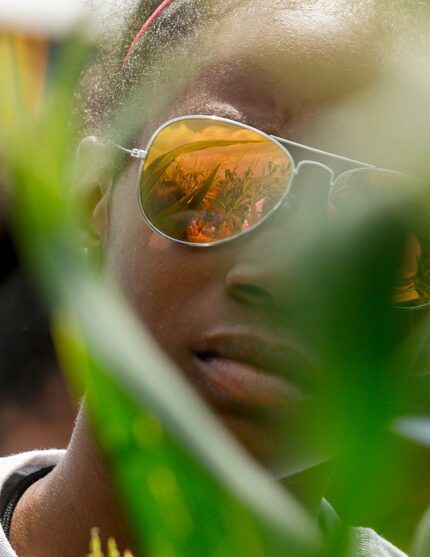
[{"left": 11, "top": 1, "right": 422, "bottom": 557}]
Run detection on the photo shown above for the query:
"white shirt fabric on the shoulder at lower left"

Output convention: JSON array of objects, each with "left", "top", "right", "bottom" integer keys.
[{"left": 0, "top": 450, "right": 64, "bottom": 557}]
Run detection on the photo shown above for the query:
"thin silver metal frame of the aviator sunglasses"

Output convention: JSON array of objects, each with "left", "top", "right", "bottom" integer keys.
[{"left": 115, "top": 114, "right": 412, "bottom": 248}]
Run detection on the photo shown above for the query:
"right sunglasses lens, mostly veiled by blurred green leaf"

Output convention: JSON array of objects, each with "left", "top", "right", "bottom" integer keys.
[{"left": 328, "top": 169, "right": 430, "bottom": 307}]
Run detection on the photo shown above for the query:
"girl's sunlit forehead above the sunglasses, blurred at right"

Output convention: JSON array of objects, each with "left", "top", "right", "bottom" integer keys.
[{"left": 149, "top": 0, "right": 424, "bottom": 165}]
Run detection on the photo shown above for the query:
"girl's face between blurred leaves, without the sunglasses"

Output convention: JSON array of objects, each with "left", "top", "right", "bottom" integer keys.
[{"left": 103, "top": 0, "right": 404, "bottom": 460}]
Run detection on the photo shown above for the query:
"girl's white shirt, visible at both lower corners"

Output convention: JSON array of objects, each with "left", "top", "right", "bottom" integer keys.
[{"left": 0, "top": 449, "right": 407, "bottom": 557}]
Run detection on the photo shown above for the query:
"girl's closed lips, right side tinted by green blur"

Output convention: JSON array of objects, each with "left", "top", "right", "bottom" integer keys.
[{"left": 194, "top": 330, "right": 310, "bottom": 410}]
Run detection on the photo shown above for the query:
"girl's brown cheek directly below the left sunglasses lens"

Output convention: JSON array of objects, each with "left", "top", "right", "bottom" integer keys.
[{"left": 106, "top": 174, "right": 223, "bottom": 350}]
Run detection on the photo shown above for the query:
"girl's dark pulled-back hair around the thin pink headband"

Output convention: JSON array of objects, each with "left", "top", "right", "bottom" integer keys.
[{"left": 78, "top": 0, "right": 235, "bottom": 139}]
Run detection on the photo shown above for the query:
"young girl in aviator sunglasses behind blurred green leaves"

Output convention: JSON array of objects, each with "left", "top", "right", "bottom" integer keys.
[{"left": 0, "top": 0, "right": 426, "bottom": 557}]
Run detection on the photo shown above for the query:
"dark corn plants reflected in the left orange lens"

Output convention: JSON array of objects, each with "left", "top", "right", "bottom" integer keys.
[{"left": 145, "top": 141, "right": 289, "bottom": 241}]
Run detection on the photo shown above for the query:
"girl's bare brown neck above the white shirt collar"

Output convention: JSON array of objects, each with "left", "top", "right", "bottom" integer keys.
[{"left": 10, "top": 409, "right": 131, "bottom": 557}]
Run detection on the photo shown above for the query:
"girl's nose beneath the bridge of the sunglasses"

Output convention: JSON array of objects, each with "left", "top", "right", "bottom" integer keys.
[{"left": 225, "top": 165, "right": 330, "bottom": 311}]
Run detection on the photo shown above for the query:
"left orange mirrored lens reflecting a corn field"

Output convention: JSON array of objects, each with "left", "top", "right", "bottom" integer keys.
[{"left": 139, "top": 117, "right": 293, "bottom": 244}]
